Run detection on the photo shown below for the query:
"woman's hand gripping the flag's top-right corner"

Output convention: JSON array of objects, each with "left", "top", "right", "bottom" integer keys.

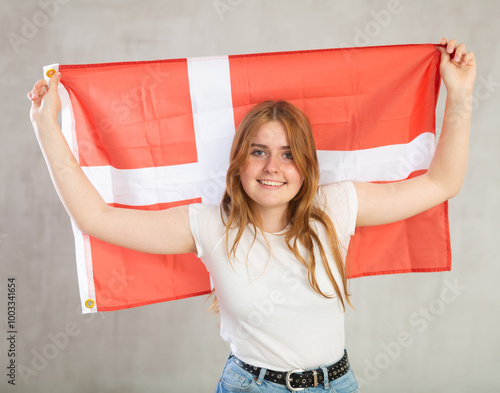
[{"left": 437, "top": 38, "right": 476, "bottom": 92}]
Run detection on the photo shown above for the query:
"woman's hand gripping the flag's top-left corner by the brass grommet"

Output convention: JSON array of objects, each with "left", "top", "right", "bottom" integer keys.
[{"left": 28, "top": 72, "right": 61, "bottom": 123}]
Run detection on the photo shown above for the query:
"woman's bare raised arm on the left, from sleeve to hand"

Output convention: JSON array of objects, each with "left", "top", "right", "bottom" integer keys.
[{"left": 28, "top": 73, "right": 196, "bottom": 254}]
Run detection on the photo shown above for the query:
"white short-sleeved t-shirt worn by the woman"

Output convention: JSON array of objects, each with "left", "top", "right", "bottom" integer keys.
[{"left": 189, "top": 182, "right": 357, "bottom": 371}]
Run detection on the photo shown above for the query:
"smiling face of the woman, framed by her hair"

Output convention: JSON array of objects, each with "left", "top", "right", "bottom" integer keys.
[{"left": 240, "top": 121, "right": 303, "bottom": 216}]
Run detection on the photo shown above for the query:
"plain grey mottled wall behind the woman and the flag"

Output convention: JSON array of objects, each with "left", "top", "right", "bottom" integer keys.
[{"left": 0, "top": 0, "right": 500, "bottom": 393}]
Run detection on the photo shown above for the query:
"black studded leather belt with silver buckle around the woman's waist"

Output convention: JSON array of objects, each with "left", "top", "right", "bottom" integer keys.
[{"left": 234, "top": 351, "right": 350, "bottom": 392}]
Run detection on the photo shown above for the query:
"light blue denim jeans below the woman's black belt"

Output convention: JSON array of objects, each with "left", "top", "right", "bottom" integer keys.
[{"left": 215, "top": 356, "right": 358, "bottom": 393}]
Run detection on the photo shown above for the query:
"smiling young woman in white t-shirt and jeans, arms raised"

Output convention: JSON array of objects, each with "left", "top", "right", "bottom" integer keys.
[{"left": 28, "top": 38, "right": 476, "bottom": 393}]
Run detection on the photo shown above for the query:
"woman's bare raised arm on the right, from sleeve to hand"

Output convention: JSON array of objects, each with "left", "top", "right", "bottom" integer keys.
[{"left": 355, "top": 38, "right": 476, "bottom": 226}]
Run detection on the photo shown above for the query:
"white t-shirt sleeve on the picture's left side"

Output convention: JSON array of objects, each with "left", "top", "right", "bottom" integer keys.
[{"left": 189, "top": 203, "right": 221, "bottom": 258}]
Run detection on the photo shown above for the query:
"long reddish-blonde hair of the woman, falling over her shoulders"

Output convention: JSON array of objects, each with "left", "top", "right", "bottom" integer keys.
[{"left": 211, "top": 101, "right": 351, "bottom": 311}]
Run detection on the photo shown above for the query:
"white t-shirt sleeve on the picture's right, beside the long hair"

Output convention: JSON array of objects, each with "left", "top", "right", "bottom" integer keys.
[{"left": 318, "top": 181, "right": 358, "bottom": 241}]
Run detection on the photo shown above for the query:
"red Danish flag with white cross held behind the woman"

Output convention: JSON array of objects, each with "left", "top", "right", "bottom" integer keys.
[{"left": 44, "top": 44, "right": 451, "bottom": 312}]
